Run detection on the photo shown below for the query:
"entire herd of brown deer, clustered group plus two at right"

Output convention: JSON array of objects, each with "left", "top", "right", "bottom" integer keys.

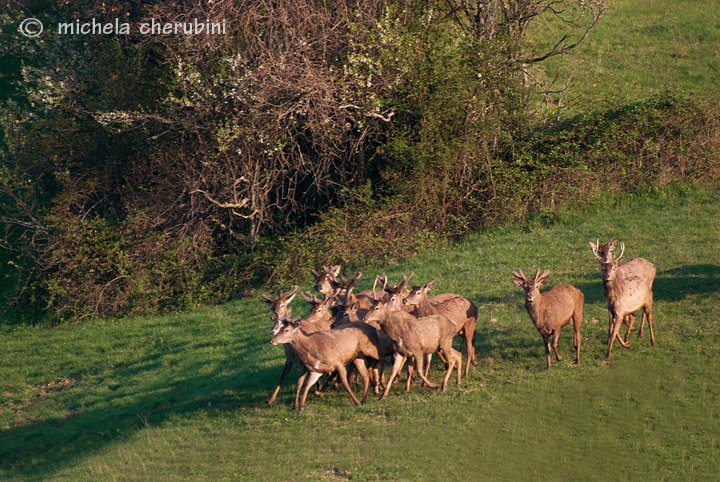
[{"left": 263, "top": 239, "right": 655, "bottom": 412}]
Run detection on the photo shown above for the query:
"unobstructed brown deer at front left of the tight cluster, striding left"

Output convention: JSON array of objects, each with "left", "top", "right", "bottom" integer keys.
[{"left": 270, "top": 317, "right": 386, "bottom": 413}]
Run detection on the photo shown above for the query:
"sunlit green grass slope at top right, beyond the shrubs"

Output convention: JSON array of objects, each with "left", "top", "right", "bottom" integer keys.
[{"left": 537, "top": 0, "right": 720, "bottom": 114}]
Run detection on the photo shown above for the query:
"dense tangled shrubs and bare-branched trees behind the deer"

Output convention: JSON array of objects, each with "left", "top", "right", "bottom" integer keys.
[{"left": 0, "top": 0, "right": 718, "bottom": 320}]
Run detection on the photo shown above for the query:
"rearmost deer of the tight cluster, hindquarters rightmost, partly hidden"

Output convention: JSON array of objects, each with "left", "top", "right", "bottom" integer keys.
[{"left": 403, "top": 280, "right": 478, "bottom": 376}]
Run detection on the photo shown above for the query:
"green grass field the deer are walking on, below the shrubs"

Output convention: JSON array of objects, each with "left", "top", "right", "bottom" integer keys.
[{"left": 0, "top": 185, "right": 720, "bottom": 481}]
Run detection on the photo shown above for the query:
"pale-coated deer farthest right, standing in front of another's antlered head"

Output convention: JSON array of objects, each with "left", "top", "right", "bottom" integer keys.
[{"left": 602, "top": 243, "right": 655, "bottom": 360}]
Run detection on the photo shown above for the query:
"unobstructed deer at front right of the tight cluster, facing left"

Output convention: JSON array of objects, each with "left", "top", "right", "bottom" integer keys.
[{"left": 363, "top": 299, "right": 462, "bottom": 401}]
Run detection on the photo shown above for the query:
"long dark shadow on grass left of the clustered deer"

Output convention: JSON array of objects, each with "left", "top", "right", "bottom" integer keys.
[{"left": 0, "top": 316, "right": 296, "bottom": 480}]
